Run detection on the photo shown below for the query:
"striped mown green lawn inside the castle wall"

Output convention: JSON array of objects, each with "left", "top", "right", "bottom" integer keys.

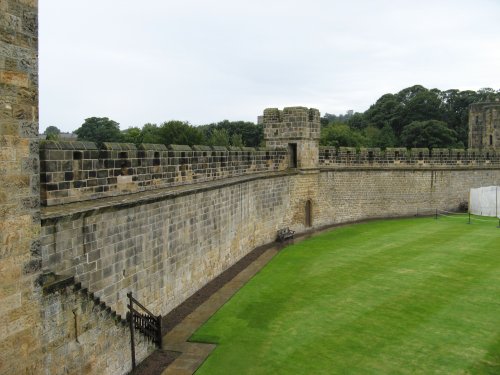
[{"left": 191, "top": 218, "right": 500, "bottom": 375}]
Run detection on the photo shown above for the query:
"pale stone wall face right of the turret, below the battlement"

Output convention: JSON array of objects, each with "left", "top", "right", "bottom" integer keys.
[{"left": 313, "top": 167, "right": 500, "bottom": 226}]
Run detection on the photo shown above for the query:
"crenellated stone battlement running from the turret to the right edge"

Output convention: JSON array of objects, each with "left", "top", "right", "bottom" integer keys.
[{"left": 319, "top": 147, "right": 500, "bottom": 168}]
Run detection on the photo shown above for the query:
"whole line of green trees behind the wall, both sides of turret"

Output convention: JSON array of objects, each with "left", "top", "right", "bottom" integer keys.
[{"left": 45, "top": 85, "right": 500, "bottom": 148}]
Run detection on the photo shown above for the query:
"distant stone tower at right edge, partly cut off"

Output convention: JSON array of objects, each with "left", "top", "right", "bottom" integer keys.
[{"left": 469, "top": 102, "right": 500, "bottom": 150}]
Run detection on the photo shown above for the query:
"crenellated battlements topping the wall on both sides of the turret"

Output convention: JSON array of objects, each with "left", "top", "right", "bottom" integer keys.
[{"left": 40, "top": 139, "right": 500, "bottom": 206}]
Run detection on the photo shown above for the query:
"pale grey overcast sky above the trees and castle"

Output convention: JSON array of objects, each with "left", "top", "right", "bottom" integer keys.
[{"left": 39, "top": 0, "right": 500, "bottom": 131}]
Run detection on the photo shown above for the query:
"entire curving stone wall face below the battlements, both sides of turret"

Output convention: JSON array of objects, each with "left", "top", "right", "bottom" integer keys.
[{"left": 41, "top": 165, "right": 500, "bottom": 326}]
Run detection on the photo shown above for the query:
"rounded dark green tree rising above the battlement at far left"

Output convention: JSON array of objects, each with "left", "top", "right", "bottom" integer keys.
[{"left": 75, "top": 117, "right": 123, "bottom": 146}]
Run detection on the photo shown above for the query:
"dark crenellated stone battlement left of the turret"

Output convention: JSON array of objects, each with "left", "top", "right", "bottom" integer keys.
[{"left": 40, "top": 141, "right": 288, "bottom": 206}]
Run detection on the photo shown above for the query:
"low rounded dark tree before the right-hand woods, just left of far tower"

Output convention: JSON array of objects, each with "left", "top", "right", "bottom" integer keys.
[{"left": 401, "top": 120, "right": 457, "bottom": 148}]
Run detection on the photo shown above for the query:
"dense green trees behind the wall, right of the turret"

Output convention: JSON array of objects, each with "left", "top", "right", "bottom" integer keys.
[{"left": 320, "top": 85, "right": 500, "bottom": 148}]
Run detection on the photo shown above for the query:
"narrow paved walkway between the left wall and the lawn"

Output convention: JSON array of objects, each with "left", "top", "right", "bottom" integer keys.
[{"left": 162, "top": 246, "right": 278, "bottom": 375}]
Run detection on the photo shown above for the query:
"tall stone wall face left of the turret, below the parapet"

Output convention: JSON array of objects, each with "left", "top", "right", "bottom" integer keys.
[{"left": 41, "top": 172, "right": 293, "bottom": 316}]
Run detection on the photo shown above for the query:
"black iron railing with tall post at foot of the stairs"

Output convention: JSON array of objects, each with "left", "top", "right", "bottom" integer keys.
[{"left": 127, "top": 292, "right": 161, "bottom": 369}]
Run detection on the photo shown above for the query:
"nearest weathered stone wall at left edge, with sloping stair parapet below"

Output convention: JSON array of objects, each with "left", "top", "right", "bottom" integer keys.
[{"left": 0, "top": 0, "right": 156, "bottom": 375}]
